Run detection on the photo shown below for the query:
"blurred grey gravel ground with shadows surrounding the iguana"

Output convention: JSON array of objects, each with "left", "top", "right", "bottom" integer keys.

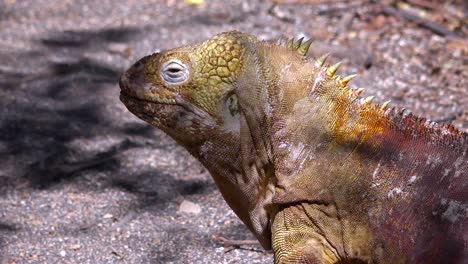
[{"left": 0, "top": 0, "right": 468, "bottom": 263}]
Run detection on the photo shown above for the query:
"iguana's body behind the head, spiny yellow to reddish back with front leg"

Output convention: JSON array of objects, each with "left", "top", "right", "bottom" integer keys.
[{"left": 236, "top": 38, "right": 468, "bottom": 263}]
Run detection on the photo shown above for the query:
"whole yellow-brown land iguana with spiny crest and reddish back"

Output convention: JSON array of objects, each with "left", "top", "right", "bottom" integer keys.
[{"left": 120, "top": 31, "right": 468, "bottom": 263}]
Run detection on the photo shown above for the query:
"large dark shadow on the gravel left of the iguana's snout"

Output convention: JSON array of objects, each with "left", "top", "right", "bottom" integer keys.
[{"left": 0, "top": 28, "right": 143, "bottom": 190}]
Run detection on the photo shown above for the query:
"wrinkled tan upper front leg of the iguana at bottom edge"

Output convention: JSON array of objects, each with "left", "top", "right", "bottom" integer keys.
[{"left": 272, "top": 203, "right": 370, "bottom": 264}]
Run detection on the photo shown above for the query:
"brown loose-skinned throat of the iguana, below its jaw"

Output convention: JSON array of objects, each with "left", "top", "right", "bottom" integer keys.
[{"left": 186, "top": 131, "right": 271, "bottom": 249}]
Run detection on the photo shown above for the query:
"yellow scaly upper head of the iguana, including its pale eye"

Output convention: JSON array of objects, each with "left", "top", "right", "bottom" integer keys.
[{"left": 145, "top": 32, "right": 255, "bottom": 117}]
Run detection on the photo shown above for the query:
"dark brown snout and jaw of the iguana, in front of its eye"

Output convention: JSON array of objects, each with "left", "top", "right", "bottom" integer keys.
[{"left": 119, "top": 53, "right": 212, "bottom": 145}]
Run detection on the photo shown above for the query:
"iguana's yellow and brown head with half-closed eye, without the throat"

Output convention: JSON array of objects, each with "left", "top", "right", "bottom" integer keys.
[{"left": 120, "top": 32, "right": 255, "bottom": 147}]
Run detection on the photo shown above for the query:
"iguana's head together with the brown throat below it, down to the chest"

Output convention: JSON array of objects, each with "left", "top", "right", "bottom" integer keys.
[{"left": 120, "top": 32, "right": 269, "bottom": 247}]
